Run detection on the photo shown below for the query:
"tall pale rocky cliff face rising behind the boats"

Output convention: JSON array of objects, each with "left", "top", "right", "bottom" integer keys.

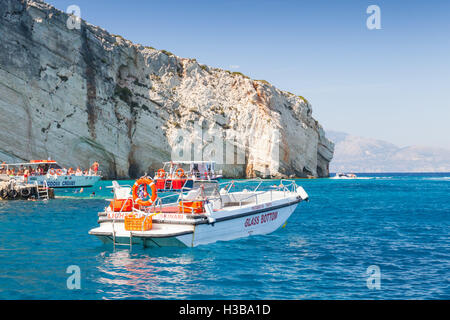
[{"left": 0, "top": 0, "right": 334, "bottom": 177}]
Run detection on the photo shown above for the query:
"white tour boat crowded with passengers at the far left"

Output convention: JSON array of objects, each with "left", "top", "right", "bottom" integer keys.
[{"left": 2, "top": 160, "right": 102, "bottom": 188}]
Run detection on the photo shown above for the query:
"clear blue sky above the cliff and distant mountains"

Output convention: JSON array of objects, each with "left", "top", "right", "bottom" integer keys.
[{"left": 47, "top": 0, "right": 450, "bottom": 149}]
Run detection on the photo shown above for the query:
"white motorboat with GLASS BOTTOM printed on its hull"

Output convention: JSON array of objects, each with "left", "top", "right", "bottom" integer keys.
[{"left": 89, "top": 177, "right": 308, "bottom": 247}]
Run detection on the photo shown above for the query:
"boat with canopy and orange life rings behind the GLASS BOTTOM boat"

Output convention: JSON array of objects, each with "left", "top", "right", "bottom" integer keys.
[{"left": 154, "top": 161, "right": 222, "bottom": 192}]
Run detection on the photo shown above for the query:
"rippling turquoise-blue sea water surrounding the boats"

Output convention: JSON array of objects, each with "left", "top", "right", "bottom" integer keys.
[{"left": 0, "top": 173, "right": 450, "bottom": 299}]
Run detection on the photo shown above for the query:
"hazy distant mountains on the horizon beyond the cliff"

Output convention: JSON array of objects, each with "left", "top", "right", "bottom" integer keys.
[{"left": 326, "top": 131, "right": 450, "bottom": 172}]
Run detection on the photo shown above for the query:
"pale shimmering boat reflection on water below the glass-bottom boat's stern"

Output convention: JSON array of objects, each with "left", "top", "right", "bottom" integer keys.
[{"left": 94, "top": 248, "right": 214, "bottom": 299}]
